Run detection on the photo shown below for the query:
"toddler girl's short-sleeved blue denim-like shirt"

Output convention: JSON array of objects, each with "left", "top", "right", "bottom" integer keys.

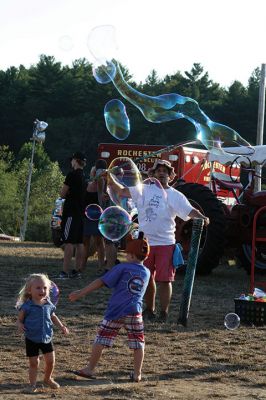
[{"left": 19, "top": 300, "right": 56, "bottom": 343}]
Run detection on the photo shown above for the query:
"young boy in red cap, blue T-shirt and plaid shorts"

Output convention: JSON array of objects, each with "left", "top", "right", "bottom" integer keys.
[{"left": 69, "top": 233, "right": 150, "bottom": 382}]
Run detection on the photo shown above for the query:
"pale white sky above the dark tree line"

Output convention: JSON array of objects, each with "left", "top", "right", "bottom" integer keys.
[{"left": 0, "top": 0, "right": 266, "bottom": 87}]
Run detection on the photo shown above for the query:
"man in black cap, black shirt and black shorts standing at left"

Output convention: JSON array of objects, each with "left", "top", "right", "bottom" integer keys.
[{"left": 59, "top": 152, "right": 86, "bottom": 279}]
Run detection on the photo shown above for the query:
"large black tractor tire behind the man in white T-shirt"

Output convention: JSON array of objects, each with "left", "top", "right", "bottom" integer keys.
[{"left": 176, "top": 183, "right": 226, "bottom": 275}]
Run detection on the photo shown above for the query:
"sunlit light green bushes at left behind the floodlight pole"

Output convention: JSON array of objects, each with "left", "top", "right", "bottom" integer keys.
[{"left": 0, "top": 143, "right": 64, "bottom": 241}]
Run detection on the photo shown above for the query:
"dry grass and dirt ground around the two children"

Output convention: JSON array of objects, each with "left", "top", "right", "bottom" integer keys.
[{"left": 0, "top": 242, "right": 266, "bottom": 400}]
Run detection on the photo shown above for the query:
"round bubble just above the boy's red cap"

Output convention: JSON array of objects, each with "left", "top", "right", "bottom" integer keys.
[{"left": 98, "top": 206, "right": 132, "bottom": 241}]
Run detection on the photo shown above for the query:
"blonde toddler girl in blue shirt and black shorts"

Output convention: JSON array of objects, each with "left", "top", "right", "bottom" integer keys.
[{"left": 17, "top": 274, "right": 69, "bottom": 392}]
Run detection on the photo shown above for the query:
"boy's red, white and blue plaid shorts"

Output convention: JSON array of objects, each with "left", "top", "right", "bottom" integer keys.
[{"left": 94, "top": 314, "right": 145, "bottom": 349}]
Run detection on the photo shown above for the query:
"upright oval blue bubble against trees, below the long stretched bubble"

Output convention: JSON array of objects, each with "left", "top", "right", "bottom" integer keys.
[{"left": 104, "top": 99, "right": 130, "bottom": 140}]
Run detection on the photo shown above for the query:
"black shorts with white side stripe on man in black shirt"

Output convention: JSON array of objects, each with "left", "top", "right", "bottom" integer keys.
[{"left": 61, "top": 216, "right": 83, "bottom": 244}]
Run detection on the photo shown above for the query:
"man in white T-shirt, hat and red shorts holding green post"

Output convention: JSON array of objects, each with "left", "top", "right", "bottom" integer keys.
[{"left": 108, "top": 159, "right": 209, "bottom": 322}]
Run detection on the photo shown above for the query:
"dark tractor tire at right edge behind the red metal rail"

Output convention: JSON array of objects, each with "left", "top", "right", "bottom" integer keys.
[{"left": 239, "top": 243, "right": 266, "bottom": 274}]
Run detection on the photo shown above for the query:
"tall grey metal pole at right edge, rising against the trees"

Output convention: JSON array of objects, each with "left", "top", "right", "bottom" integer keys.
[{"left": 254, "top": 64, "right": 266, "bottom": 192}]
